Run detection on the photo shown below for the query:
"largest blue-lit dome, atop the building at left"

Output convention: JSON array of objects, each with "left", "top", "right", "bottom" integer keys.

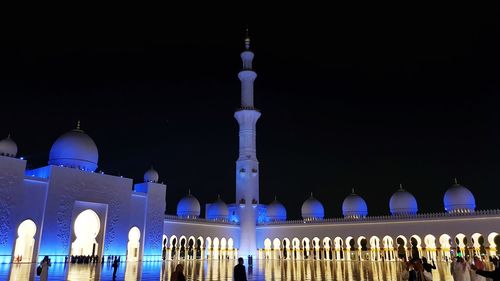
[{"left": 49, "top": 126, "right": 99, "bottom": 171}]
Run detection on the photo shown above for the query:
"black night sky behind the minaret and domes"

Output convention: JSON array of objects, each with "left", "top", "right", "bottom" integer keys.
[{"left": 0, "top": 10, "right": 500, "bottom": 218}]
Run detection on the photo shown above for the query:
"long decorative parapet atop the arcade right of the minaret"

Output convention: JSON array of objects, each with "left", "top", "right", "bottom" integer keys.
[{"left": 259, "top": 209, "right": 500, "bottom": 225}]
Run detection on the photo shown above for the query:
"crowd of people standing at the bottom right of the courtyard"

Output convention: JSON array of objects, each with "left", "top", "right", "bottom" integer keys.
[{"left": 402, "top": 255, "right": 500, "bottom": 281}]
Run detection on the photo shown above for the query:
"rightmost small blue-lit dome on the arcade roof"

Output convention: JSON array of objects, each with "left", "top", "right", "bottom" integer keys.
[{"left": 443, "top": 180, "right": 476, "bottom": 213}]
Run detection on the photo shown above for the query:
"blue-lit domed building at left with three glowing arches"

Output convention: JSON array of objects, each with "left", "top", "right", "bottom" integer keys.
[{"left": 0, "top": 129, "right": 166, "bottom": 262}]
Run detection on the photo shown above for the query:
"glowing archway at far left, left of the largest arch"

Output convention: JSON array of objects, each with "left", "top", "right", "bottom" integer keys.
[{"left": 13, "top": 220, "right": 36, "bottom": 262}]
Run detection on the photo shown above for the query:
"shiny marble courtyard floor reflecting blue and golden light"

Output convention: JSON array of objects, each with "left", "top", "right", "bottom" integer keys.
[{"left": 0, "top": 260, "right": 464, "bottom": 281}]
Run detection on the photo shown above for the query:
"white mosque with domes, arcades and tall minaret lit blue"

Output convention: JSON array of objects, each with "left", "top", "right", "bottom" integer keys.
[{"left": 0, "top": 32, "right": 500, "bottom": 263}]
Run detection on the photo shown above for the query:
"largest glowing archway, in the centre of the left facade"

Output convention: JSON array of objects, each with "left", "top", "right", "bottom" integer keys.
[{"left": 71, "top": 209, "right": 101, "bottom": 256}]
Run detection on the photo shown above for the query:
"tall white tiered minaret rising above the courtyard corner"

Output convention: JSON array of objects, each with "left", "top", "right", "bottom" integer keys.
[{"left": 234, "top": 29, "right": 260, "bottom": 257}]
